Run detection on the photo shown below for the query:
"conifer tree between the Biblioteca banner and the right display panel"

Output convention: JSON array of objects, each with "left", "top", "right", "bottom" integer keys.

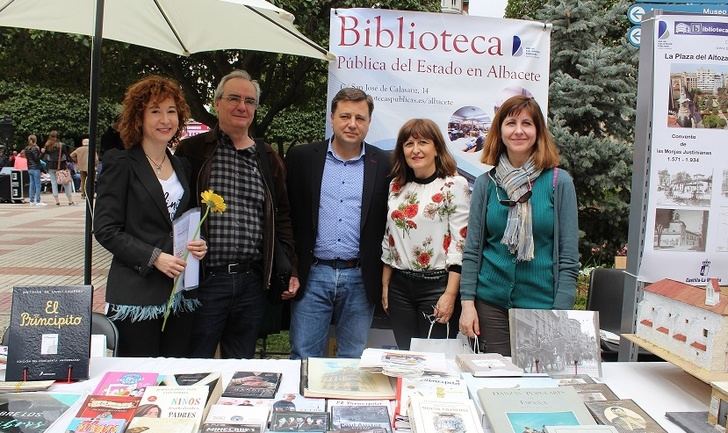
[{"left": 534, "top": 0, "right": 637, "bottom": 263}]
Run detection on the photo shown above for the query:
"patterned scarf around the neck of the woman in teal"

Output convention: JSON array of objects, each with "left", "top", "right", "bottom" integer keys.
[{"left": 495, "top": 152, "right": 541, "bottom": 262}]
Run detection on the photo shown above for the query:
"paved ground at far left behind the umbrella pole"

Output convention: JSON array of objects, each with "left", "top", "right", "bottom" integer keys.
[{"left": 0, "top": 193, "right": 111, "bottom": 335}]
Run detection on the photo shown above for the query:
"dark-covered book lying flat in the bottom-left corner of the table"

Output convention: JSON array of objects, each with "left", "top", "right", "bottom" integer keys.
[{"left": 0, "top": 392, "right": 81, "bottom": 433}]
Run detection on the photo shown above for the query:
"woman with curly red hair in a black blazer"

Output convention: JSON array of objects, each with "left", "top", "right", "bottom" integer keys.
[{"left": 94, "top": 75, "right": 207, "bottom": 357}]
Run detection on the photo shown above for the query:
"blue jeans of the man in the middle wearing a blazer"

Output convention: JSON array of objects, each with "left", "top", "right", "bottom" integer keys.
[{"left": 290, "top": 264, "right": 374, "bottom": 359}]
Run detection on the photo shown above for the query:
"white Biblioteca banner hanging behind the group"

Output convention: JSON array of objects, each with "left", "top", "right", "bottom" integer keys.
[{"left": 326, "top": 9, "right": 551, "bottom": 177}]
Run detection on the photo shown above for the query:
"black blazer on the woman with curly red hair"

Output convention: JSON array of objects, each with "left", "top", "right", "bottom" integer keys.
[{"left": 94, "top": 146, "right": 194, "bottom": 305}]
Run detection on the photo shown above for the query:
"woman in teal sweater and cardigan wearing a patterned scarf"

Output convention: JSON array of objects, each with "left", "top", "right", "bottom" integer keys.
[{"left": 460, "top": 96, "right": 579, "bottom": 356}]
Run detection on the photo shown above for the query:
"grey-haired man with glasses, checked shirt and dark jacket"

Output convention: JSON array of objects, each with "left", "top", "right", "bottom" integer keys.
[{"left": 176, "top": 70, "right": 298, "bottom": 358}]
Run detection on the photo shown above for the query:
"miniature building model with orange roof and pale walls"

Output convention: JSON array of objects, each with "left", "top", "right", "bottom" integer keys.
[{"left": 637, "top": 279, "right": 728, "bottom": 372}]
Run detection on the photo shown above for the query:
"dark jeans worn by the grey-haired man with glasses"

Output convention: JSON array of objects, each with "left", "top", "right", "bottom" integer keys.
[{"left": 191, "top": 271, "right": 267, "bottom": 359}]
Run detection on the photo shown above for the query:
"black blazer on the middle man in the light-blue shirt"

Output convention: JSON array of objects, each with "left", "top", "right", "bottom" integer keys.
[{"left": 286, "top": 140, "right": 390, "bottom": 305}]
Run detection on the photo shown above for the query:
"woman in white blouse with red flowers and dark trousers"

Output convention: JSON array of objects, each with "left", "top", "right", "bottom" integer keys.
[{"left": 382, "top": 119, "right": 470, "bottom": 350}]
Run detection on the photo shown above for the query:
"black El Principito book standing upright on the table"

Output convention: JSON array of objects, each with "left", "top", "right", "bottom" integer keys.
[{"left": 5, "top": 286, "right": 92, "bottom": 381}]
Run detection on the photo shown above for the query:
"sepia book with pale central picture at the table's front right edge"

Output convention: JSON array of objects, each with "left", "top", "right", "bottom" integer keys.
[{"left": 586, "top": 400, "right": 665, "bottom": 433}]
